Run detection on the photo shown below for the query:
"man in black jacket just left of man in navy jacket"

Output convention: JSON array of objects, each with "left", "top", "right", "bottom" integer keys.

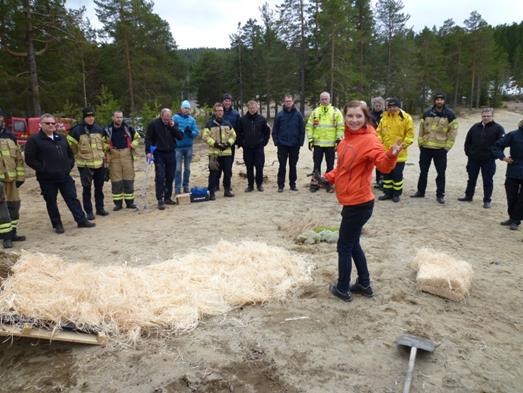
[{"left": 236, "top": 100, "right": 271, "bottom": 192}]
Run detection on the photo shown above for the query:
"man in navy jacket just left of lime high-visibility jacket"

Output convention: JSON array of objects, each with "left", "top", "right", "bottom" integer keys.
[{"left": 272, "top": 94, "right": 305, "bottom": 192}]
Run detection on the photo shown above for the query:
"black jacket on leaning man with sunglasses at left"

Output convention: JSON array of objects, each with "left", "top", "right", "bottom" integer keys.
[{"left": 25, "top": 130, "right": 74, "bottom": 181}]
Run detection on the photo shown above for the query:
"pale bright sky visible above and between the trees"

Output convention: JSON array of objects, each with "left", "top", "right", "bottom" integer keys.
[{"left": 66, "top": 0, "right": 523, "bottom": 48}]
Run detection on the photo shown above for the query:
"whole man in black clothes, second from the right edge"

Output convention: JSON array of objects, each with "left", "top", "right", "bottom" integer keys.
[{"left": 458, "top": 108, "right": 505, "bottom": 205}]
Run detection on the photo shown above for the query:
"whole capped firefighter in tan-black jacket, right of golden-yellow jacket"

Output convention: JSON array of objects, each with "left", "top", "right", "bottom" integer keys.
[{"left": 411, "top": 93, "right": 458, "bottom": 204}]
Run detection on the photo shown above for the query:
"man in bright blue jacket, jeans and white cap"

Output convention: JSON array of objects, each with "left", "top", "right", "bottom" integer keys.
[{"left": 173, "top": 100, "right": 200, "bottom": 194}]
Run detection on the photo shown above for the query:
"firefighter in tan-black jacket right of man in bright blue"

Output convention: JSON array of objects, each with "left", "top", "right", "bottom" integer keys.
[{"left": 202, "top": 102, "right": 236, "bottom": 201}]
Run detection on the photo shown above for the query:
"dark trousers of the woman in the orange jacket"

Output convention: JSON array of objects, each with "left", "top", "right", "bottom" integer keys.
[{"left": 337, "top": 201, "right": 374, "bottom": 292}]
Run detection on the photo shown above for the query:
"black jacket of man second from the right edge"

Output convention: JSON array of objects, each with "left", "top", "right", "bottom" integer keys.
[{"left": 465, "top": 121, "right": 505, "bottom": 161}]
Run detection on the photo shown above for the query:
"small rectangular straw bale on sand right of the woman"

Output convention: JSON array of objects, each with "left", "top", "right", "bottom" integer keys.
[{"left": 414, "top": 248, "right": 473, "bottom": 301}]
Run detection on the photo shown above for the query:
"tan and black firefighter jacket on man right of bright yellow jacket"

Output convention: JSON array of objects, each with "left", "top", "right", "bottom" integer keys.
[{"left": 418, "top": 107, "right": 458, "bottom": 151}]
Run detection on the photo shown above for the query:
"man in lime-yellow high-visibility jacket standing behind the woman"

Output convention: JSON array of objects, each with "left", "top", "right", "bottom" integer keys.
[{"left": 306, "top": 91, "right": 345, "bottom": 192}]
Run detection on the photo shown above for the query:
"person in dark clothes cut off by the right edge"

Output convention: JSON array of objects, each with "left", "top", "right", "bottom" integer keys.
[{"left": 494, "top": 120, "right": 523, "bottom": 230}]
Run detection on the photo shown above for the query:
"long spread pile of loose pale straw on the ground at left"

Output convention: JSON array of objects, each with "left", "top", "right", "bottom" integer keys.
[{"left": 0, "top": 241, "right": 311, "bottom": 341}]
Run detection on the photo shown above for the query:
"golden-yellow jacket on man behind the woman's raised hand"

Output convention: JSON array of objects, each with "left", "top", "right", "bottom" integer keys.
[{"left": 377, "top": 109, "right": 414, "bottom": 162}]
